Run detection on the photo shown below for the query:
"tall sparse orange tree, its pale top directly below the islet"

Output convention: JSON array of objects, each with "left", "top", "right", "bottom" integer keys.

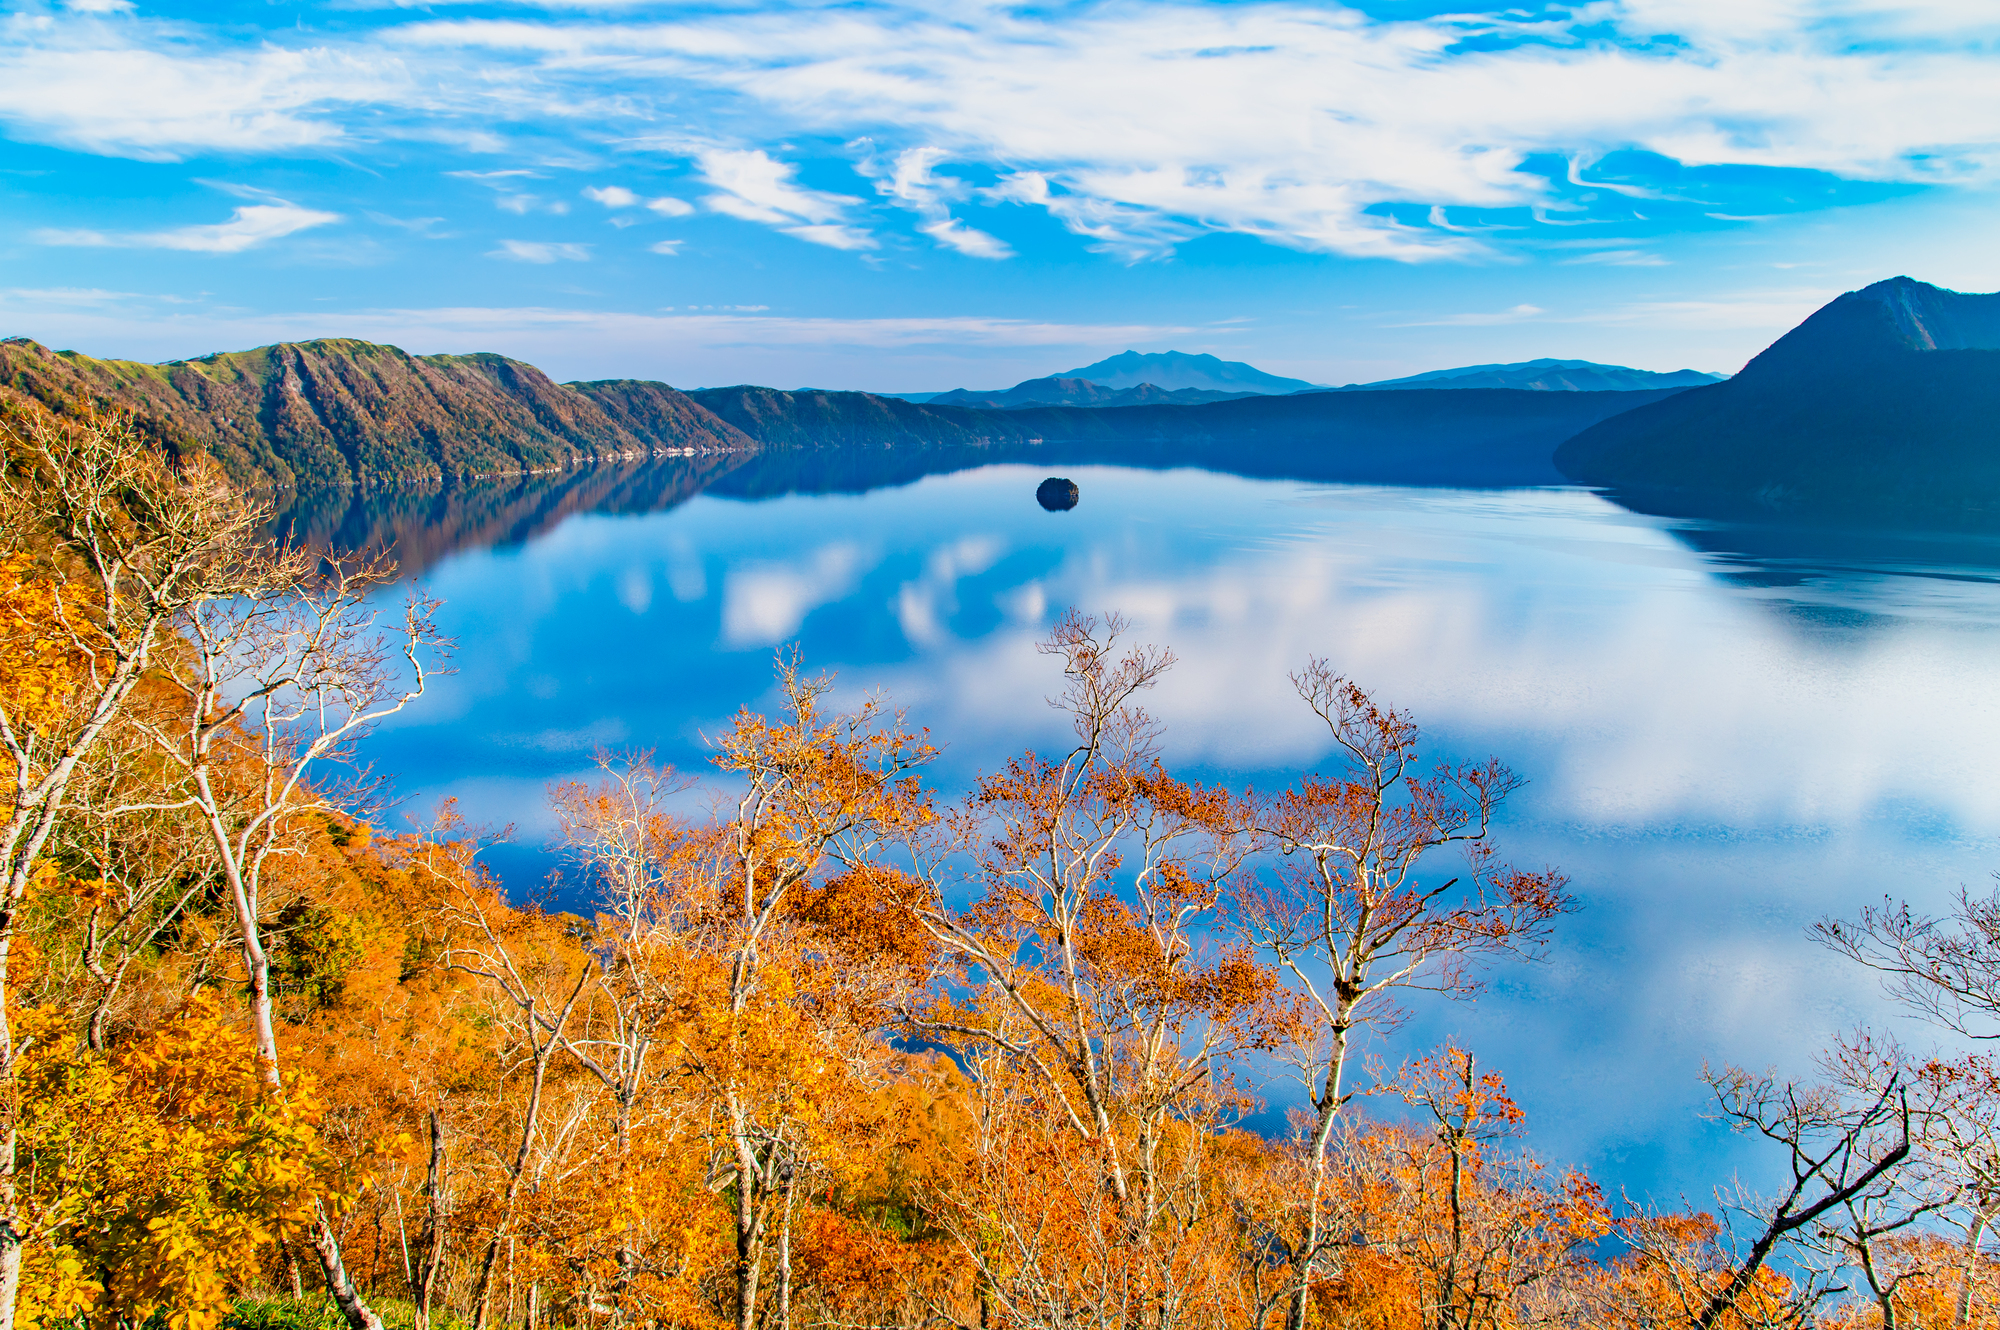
[{"left": 910, "top": 612, "right": 1272, "bottom": 1330}]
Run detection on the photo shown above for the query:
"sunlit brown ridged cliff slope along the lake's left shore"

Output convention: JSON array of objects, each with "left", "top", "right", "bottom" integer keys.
[{"left": 0, "top": 338, "right": 754, "bottom": 488}]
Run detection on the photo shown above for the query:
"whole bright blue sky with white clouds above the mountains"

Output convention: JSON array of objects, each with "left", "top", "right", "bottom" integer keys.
[{"left": 0, "top": 0, "right": 2000, "bottom": 392}]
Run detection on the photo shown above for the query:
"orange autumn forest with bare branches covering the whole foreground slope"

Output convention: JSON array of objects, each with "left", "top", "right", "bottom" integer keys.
[{"left": 0, "top": 410, "right": 2000, "bottom": 1330}]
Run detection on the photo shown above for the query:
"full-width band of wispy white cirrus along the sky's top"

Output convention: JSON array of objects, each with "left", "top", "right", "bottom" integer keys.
[{"left": 0, "top": 0, "right": 2000, "bottom": 262}]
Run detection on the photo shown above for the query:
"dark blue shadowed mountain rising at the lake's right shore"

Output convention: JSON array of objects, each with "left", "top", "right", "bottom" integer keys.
[{"left": 1556, "top": 278, "right": 2000, "bottom": 522}]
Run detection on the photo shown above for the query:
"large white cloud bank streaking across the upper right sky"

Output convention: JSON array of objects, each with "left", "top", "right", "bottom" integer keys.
[{"left": 400, "top": 0, "right": 2000, "bottom": 260}]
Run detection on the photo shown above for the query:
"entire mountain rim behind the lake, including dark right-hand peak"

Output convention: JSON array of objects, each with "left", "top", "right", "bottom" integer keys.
[{"left": 23, "top": 278, "right": 2000, "bottom": 522}]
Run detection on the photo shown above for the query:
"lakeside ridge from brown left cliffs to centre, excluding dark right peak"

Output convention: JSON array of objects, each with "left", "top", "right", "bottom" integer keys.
[{"left": 0, "top": 338, "right": 1704, "bottom": 490}]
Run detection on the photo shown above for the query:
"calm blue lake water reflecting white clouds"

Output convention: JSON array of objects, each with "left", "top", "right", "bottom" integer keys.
[{"left": 352, "top": 466, "right": 2000, "bottom": 1204}]
